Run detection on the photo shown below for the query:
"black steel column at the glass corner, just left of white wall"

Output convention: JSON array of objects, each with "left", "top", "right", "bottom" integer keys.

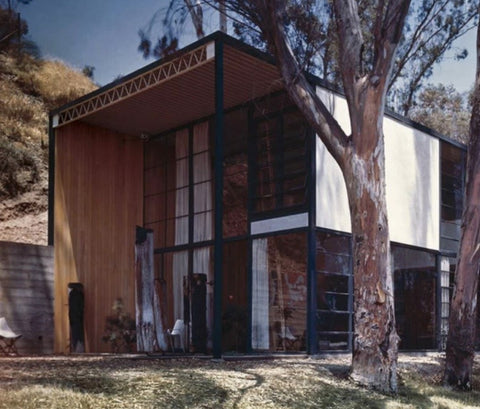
[{"left": 307, "top": 130, "right": 318, "bottom": 354}]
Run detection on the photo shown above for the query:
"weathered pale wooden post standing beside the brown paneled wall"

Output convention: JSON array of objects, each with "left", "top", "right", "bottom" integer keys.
[{"left": 135, "top": 226, "right": 167, "bottom": 352}]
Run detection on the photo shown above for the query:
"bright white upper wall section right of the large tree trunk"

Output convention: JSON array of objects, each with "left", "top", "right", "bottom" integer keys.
[{"left": 383, "top": 118, "right": 440, "bottom": 250}]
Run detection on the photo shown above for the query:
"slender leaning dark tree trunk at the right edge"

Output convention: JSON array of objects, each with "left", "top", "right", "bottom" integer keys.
[{"left": 444, "top": 18, "right": 480, "bottom": 390}]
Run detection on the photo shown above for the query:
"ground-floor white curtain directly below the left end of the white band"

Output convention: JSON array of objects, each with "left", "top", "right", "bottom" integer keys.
[{"left": 252, "top": 239, "right": 270, "bottom": 350}]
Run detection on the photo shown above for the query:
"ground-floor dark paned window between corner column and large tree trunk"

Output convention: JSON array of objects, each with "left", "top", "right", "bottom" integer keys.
[{"left": 316, "top": 232, "right": 352, "bottom": 350}]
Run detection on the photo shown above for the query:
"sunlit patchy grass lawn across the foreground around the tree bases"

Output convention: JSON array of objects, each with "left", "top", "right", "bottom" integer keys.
[{"left": 0, "top": 353, "right": 480, "bottom": 409}]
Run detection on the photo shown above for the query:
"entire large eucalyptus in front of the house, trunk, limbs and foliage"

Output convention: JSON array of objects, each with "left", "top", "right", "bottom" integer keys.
[{"left": 140, "top": 0, "right": 476, "bottom": 391}]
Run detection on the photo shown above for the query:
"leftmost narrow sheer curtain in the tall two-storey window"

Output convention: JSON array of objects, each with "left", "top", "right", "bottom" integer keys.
[{"left": 173, "top": 129, "right": 189, "bottom": 320}]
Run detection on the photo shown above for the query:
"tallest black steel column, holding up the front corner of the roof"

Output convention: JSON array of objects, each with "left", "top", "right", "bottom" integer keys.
[{"left": 213, "top": 38, "right": 224, "bottom": 359}]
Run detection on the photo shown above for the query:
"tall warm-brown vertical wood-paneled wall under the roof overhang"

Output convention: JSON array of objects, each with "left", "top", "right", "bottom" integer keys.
[{"left": 54, "top": 122, "right": 143, "bottom": 353}]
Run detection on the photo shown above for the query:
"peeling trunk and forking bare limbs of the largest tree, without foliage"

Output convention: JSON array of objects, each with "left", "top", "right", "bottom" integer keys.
[{"left": 249, "top": 0, "right": 410, "bottom": 392}]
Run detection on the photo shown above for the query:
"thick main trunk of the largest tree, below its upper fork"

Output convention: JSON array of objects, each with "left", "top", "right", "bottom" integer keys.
[{"left": 344, "top": 93, "right": 398, "bottom": 392}]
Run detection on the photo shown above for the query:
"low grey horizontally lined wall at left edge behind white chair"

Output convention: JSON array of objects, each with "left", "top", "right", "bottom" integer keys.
[{"left": 0, "top": 242, "right": 53, "bottom": 355}]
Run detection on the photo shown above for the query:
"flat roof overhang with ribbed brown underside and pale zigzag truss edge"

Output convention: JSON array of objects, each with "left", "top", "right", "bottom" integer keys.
[{"left": 52, "top": 33, "right": 283, "bottom": 136}]
